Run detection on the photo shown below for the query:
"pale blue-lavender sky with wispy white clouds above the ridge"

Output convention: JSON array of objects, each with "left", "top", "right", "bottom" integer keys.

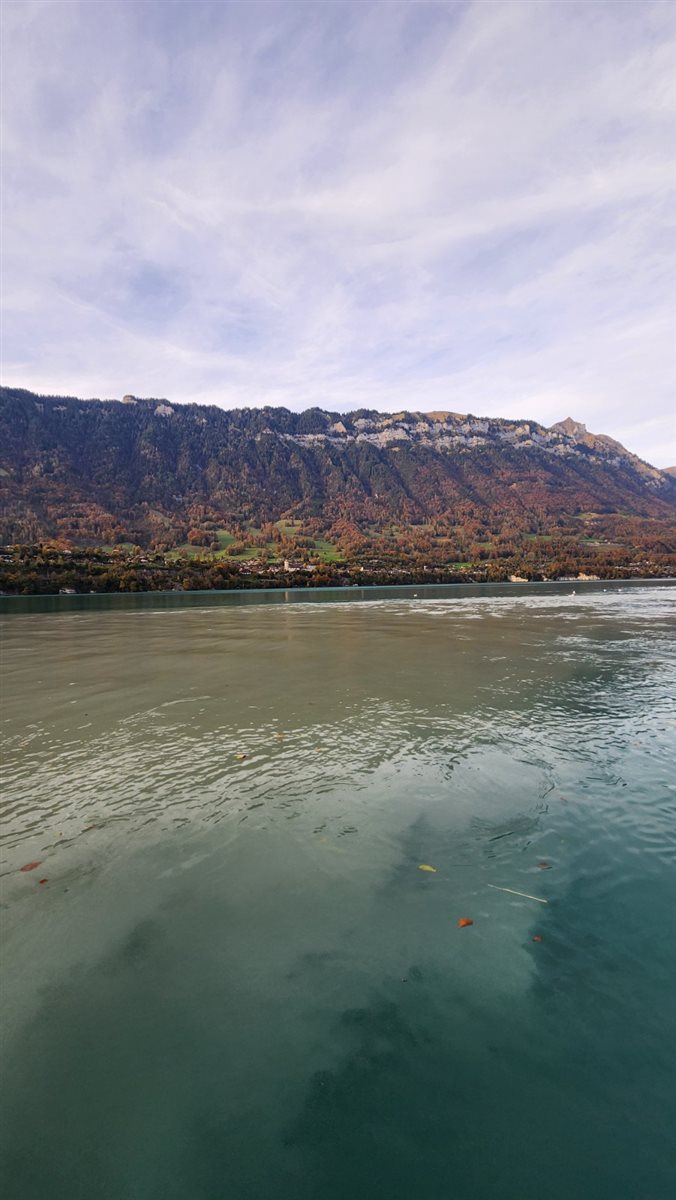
[{"left": 1, "top": 0, "right": 676, "bottom": 467}]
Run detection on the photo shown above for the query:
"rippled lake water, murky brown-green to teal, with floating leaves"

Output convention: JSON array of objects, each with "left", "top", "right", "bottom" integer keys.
[{"left": 0, "top": 583, "right": 676, "bottom": 1200}]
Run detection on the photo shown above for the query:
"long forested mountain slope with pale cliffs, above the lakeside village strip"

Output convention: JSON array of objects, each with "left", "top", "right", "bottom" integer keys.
[{"left": 0, "top": 388, "right": 676, "bottom": 544}]
